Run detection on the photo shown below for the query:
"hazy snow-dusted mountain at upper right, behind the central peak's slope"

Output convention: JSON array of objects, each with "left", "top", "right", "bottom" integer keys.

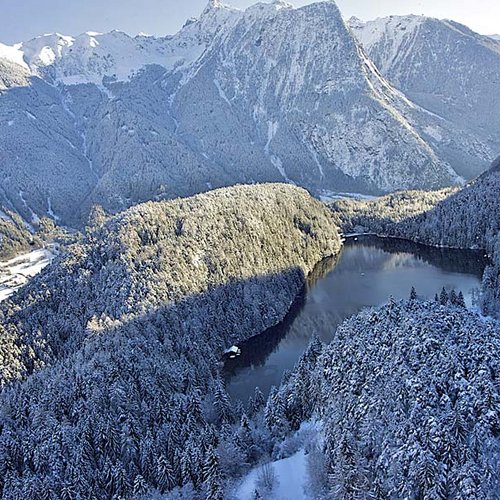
[{"left": 349, "top": 15, "right": 500, "bottom": 178}]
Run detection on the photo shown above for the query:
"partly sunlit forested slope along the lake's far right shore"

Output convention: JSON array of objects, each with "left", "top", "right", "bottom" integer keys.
[{"left": 332, "top": 159, "right": 500, "bottom": 316}]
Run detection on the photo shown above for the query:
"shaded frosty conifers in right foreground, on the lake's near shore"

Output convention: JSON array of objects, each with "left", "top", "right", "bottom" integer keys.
[{"left": 258, "top": 298, "right": 500, "bottom": 499}]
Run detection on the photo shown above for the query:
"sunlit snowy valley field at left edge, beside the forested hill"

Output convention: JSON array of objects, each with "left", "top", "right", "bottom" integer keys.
[{"left": 0, "top": 248, "right": 57, "bottom": 302}]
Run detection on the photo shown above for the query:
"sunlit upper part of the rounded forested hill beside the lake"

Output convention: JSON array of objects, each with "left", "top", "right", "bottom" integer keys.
[{"left": 0, "top": 185, "right": 340, "bottom": 387}]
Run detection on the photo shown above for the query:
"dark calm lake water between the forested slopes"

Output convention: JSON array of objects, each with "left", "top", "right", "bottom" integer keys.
[{"left": 225, "top": 236, "right": 487, "bottom": 401}]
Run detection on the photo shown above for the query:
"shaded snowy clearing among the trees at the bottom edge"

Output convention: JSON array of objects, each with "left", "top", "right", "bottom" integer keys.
[{"left": 235, "top": 450, "right": 308, "bottom": 500}]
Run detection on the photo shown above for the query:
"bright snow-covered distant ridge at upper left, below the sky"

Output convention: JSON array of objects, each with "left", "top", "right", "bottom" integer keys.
[{"left": 0, "top": 1, "right": 242, "bottom": 85}]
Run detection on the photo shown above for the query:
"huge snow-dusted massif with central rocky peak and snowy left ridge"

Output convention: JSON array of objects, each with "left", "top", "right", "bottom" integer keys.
[{"left": 0, "top": 0, "right": 468, "bottom": 226}]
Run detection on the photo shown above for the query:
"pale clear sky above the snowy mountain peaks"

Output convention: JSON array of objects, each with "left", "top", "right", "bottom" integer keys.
[{"left": 0, "top": 0, "right": 500, "bottom": 43}]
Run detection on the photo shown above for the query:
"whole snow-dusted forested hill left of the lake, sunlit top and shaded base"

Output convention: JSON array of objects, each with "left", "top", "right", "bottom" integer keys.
[{"left": 0, "top": 185, "right": 341, "bottom": 499}]
